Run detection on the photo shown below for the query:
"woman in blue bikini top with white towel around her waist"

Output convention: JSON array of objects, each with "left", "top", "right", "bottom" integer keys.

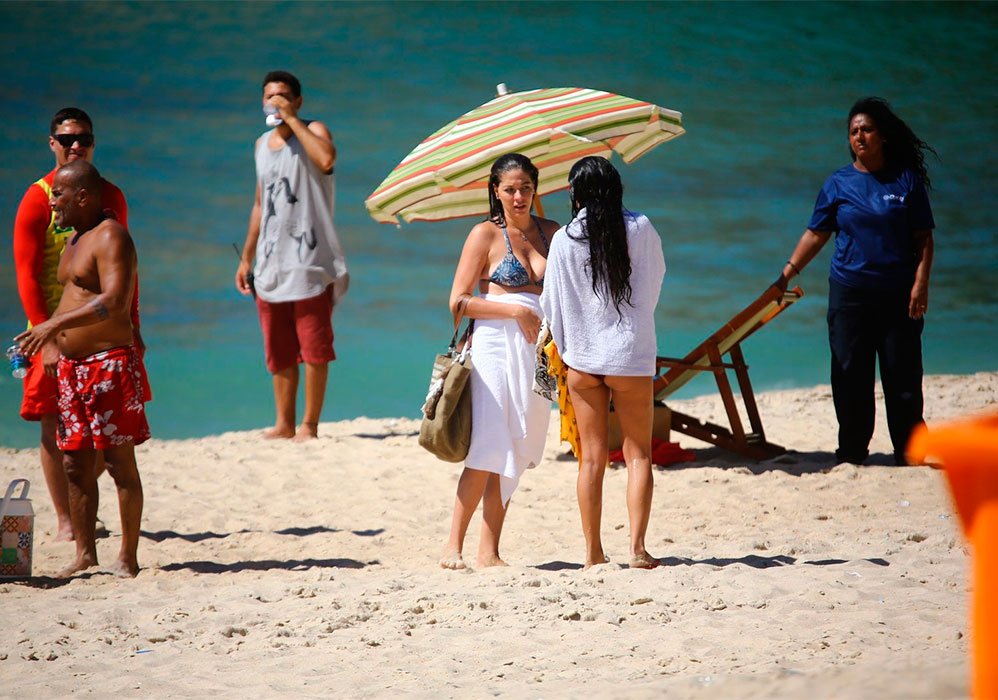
[{"left": 440, "top": 153, "right": 558, "bottom": 569}]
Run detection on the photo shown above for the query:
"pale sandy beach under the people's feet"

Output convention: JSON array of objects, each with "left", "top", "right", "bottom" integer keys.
[{"left": 0, "top": 373, "right": 998, "bottom": 698}]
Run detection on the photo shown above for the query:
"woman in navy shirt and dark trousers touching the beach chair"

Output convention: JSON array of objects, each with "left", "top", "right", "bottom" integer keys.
[{"left": 776, "top": 97, "right": 935, "bottom": 464}]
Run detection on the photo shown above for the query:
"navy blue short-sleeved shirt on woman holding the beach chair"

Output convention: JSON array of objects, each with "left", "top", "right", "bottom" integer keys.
[{"left": 807, "top": 164, "right": 936, "bottom": 291}]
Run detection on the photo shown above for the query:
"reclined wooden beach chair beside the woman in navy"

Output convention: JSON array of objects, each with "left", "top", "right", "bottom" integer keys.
[{"left": 654, "top": 286, "right": 804, "bottom": 460}]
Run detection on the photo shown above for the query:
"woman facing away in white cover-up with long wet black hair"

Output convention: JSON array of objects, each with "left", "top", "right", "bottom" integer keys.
[{"left": 541, "top": 156, "right": 665, "bottom": 569}]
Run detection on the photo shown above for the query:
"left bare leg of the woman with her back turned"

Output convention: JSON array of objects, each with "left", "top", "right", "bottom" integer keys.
[{"left": 568, "top": 369, "right": 610, "bottom": 569}]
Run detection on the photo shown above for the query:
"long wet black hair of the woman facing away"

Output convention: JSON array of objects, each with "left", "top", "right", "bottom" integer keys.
[{"left": 568, "top": 156, "right": 631, "bottom": 314}]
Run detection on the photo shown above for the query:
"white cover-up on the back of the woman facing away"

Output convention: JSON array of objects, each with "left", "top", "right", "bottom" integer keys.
[{"left": 541, "top": 209, "right": 665, "bottom": 377}]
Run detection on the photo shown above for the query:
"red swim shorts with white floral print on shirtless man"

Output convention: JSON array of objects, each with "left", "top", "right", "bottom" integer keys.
[{"left": 56, "top": 345, "right": 149, "bottom": 450}]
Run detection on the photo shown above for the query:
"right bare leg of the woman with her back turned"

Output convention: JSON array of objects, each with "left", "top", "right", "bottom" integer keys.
[{"left": 604, "top": 377, "right": 658, "bottom": 568}]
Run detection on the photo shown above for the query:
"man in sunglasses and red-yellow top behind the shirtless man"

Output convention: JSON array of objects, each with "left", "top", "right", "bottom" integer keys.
[{"left": 14, "top": 107, "right": 148, "bottom": 541}]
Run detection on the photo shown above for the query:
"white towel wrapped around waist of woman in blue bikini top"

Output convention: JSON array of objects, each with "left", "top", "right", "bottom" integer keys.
[{"left": 464, "top": 292, "right": 551, "bottom": 505}]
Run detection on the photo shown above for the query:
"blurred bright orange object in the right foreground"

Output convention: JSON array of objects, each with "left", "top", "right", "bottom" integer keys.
[{"left": 908, "top": 412, "right": 998, "bottom": 698}]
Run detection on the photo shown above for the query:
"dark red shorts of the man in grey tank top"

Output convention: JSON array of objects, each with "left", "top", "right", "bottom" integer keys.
[{"left": 256, "top": 285, "right": 336, "bottom": 372}]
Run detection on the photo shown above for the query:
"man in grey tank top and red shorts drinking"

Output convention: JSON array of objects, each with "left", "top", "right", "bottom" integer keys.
[{"left": 236, "top": 71, "right": 350, "bottom": 440}]
